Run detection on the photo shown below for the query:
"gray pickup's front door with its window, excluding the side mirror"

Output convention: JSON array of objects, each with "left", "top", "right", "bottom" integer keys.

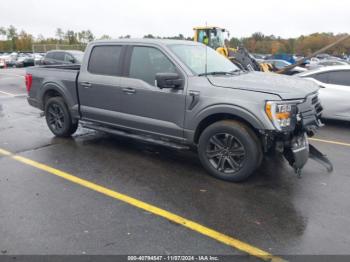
[{"left": 121, "top": 45, "right": 185, "bottom": 138}]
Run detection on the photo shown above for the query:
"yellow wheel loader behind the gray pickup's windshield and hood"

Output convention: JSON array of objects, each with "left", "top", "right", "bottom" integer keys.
[{"left": 193, "top": 26, "right": 275, "bottom": 72}]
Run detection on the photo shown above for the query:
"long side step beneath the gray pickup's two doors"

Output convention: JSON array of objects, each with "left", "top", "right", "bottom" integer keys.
[{"left": 81, "top": 122, "right": 190, "bottom": 150}]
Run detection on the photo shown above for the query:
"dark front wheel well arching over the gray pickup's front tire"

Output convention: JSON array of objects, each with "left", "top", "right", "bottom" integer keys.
[{"left": 194, "top": 114, "right": 259, "bottom": 144}]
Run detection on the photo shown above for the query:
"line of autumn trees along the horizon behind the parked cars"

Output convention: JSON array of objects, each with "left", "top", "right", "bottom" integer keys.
[{"left": 0, "top": 25, "right": 350, "bottom": 55}]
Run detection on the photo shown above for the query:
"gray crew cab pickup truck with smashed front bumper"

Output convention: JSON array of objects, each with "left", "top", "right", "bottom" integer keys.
[{"left": 25, "top": 39, "right": 331, "bottom": 181}]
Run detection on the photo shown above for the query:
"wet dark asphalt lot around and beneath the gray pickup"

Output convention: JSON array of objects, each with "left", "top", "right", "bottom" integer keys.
[{"left": 0, "top": 69, "right": 350, "bottom": 257}]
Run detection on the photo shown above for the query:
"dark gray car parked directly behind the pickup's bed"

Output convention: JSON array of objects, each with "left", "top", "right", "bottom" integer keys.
[{"left": 42, "top": 50, "right": 84, "bottom": 65}]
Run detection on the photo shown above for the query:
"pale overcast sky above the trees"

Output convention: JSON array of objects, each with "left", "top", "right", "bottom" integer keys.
[{"left": 0, "top": 0, "right": 350, "bottom": 38}]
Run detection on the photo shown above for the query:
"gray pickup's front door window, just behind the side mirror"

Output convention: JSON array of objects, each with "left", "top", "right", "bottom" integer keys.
[{"left": 129, "top": 46, "right": 177, "bottom": 86}]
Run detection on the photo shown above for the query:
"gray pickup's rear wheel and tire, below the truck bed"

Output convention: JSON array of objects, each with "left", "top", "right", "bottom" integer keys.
[{"left": 45, "top": 97, "right": 78, "bottom": 137}]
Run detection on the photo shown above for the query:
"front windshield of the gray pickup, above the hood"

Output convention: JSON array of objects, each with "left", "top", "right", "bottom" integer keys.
[{"left": 169, "top": 44, "right": 239, "bottom": 75}]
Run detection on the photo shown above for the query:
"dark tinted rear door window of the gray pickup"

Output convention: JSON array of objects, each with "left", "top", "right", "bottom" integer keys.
[{"left": 88, "top": 45, "right": 122, "bottom": 76}]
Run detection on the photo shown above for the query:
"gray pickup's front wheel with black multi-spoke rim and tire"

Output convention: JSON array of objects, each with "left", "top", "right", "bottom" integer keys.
[{"left": 198, "top": 120, "right": 263, "bottom": 182}]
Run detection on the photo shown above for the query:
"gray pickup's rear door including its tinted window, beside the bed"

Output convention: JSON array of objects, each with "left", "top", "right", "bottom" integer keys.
[{"left": 78, "top": 44, "right": 124, "bottom": 125}]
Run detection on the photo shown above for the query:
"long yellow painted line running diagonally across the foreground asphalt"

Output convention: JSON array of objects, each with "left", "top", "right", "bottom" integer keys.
[{"left": 0, "top": 148, "right": 284, "bottom": 261}]
